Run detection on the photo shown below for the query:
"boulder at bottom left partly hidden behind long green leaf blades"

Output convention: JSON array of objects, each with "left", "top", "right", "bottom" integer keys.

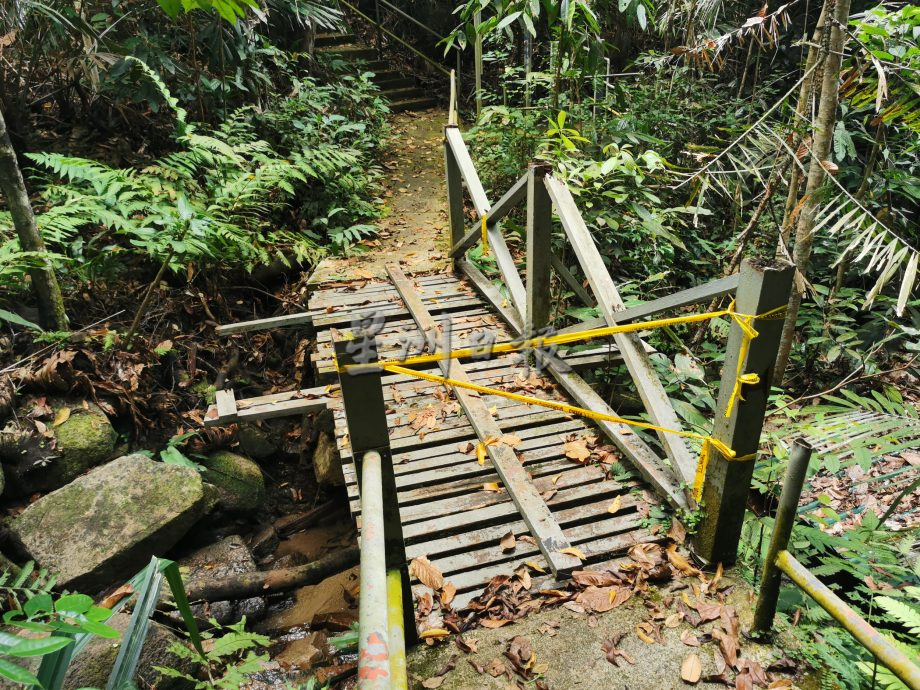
[{"left": 63, "top": 613, "right": 195, "bottom": 690}]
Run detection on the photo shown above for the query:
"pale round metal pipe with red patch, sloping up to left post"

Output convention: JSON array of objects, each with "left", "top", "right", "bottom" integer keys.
[{"left": 358, "top": 450, "right": 391, "bottom": 690}]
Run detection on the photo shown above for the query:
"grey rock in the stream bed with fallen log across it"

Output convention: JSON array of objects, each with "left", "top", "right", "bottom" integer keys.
[{"left": 179, "top": 534, "right": 265, "bottom": 625}]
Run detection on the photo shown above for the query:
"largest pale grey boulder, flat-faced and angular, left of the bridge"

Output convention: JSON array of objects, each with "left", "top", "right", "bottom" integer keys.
[{"left": 10, "top": 455, "right": 208, "bottom": 592}]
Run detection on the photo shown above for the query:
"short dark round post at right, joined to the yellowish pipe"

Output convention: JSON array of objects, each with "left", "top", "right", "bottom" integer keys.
[{"left": 751, "top": 439, "right": 811, "bottom": 636}]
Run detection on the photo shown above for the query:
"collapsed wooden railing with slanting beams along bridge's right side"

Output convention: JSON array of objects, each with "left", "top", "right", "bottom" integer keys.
[{"left": 444, "top": 115, "right": 793, "bottom": 562}]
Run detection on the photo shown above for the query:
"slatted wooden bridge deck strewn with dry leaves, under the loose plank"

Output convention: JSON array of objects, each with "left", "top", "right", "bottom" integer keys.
[{"left": 309, "top": 266, "right": 657, "bottom": 607}]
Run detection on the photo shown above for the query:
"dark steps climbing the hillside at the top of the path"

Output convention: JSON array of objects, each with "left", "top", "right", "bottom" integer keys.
[{"left": 314, "top": 33, "right": 438, "bottom": 113}]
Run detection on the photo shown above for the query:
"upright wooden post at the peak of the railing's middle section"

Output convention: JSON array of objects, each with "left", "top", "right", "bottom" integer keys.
[{"left": 523, "top": 163, "right": 553, "bottom": 332}]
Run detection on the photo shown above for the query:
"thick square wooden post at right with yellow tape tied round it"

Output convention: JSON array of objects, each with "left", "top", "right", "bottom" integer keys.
[{"left": 693, "top": 259, "right": 794, "bottom": 565}]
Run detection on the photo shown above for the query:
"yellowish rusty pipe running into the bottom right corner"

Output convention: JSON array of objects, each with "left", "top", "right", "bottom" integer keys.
[{"left": 776, "top": 551, "right": 920, "bottom": 690}]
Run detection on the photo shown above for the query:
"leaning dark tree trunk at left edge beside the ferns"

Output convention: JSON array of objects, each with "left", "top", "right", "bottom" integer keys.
[{"left": 0, "top": 105, "right": 67, "bottom": 331}]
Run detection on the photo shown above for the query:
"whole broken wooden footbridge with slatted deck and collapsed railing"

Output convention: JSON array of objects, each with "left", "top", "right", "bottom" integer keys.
[{"left": 206, "top": 110, "right": 792, "bottom": 676}]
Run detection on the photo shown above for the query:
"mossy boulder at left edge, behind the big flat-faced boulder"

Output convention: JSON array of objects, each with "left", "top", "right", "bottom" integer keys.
[{"left": 0, "top": 399, "right": 118, "bottom": 495}]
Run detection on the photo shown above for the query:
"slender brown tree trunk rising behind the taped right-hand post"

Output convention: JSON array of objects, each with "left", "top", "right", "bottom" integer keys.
[{"left": 774, "top": 0, "right": 850, "bottom": 383}]
